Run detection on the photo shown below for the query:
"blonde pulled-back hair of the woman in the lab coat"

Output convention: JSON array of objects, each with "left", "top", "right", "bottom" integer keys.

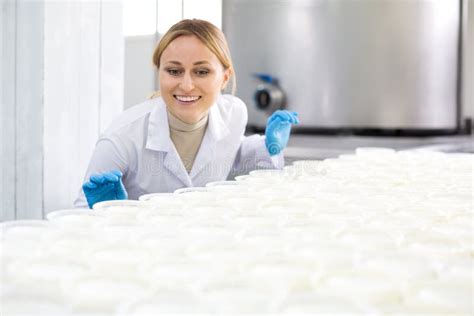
[{"left": 151, "top": 19, "right": 236, "bottom": 98}]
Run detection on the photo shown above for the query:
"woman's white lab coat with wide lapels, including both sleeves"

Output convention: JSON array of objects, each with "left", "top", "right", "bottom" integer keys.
[{"left": 74, "top": 95, "right": 284, "bottom": 207}]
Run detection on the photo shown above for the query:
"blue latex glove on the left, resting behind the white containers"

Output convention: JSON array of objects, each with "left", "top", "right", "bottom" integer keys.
[{"left": 82, "top": 170, "right": 128, "bottom": 208}]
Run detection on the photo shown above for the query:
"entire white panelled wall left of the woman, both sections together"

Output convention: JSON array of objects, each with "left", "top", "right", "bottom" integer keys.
[{"left": 0, "top": 0, "right": 123, "bottom": 220}]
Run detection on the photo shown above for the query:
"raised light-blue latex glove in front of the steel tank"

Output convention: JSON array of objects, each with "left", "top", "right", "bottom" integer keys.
[{"left": 265, "top": 110, "right": 300, "bottom": 156}]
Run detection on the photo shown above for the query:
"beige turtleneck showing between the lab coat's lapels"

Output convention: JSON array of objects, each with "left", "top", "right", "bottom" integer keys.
[{"left": 168, "top": 110, "right": 209, "bottom": 173}]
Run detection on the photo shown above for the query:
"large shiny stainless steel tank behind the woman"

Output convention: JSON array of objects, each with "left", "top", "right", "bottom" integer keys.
[{"left": 223, "top": 0, "right": 460, "bottom": 131}]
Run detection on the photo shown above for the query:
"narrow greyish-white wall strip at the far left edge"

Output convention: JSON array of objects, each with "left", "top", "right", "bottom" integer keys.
[{"left": 0, "top": 0, "right": 44, "bottom": 220}]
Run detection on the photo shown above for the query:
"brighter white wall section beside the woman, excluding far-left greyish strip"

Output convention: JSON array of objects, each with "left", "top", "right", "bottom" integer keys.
[{"left": 44, "top": 1, "right": 123, "bottom": 212}]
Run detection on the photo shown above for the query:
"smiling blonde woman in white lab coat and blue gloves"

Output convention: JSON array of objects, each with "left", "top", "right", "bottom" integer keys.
[{"left": 75, "top": 19, "right": 298, "bottom": 208}]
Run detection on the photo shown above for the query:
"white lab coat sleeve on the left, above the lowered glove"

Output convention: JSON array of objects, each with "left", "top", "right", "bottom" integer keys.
[{"left": 74, "top": 138, "right": 128, "bottom": 208}]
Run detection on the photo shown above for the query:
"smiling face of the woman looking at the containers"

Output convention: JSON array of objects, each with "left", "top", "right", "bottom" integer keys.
[{"left": 158, "top": 35, "right": 231, "bottom": 124}]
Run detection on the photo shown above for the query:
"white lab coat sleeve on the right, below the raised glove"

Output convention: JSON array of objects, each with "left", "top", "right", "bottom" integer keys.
[{"left": 228, "top": 135, "right": 285, "bottom": 179}]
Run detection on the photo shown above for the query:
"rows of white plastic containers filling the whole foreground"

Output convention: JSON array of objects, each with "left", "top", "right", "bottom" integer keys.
[{"left": 0, "top": 148, "right": 474, "bottom": 315}]
